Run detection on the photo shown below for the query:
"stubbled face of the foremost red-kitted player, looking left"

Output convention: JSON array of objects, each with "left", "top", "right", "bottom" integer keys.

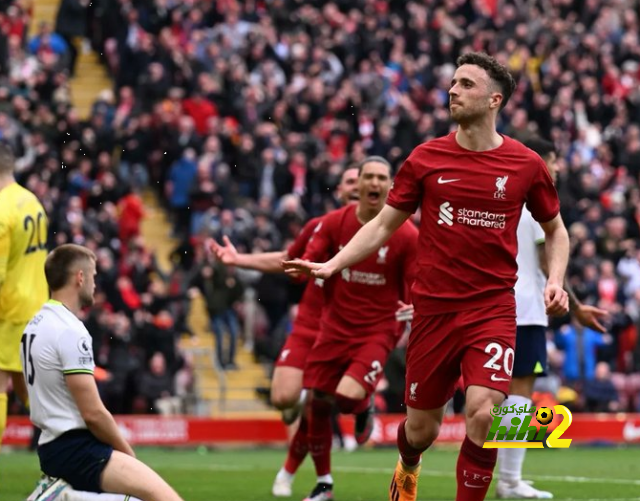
[{"left": 449, "top": 64, "right": 502, "bottom": 125}]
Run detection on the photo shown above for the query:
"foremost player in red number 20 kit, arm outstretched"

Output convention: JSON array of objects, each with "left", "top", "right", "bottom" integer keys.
[{"left": 290, "top": 53, "right": 569, "bottom": 501}]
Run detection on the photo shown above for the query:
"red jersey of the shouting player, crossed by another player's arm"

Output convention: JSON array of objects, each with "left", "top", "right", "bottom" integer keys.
[{"left": 304, "top": 205, "right": 418, "bottom": 337}]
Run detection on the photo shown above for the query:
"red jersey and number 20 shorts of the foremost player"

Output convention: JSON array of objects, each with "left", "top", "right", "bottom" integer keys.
[{"left": 387, "top": 129, "right": 559, "bottom": 409}]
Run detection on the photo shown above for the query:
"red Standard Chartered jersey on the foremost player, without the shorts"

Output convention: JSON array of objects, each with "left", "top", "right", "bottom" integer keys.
[{"left": 387, "top": 132, "right": 560, "bottom": 315}]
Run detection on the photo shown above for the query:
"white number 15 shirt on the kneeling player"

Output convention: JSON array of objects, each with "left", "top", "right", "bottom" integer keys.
[{"left": 20, "top": 300, "right": 95, "bottom": 445}]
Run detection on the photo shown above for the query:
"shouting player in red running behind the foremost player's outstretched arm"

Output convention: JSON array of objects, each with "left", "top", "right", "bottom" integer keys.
[{"left": 285, "top": 159, "right": 418, "bottom": 501}]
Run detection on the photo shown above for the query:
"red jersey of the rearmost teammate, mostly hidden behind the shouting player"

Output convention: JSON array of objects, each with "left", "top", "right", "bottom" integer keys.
[{"left": 287, "top": 216, "right": 324, "bottom": 332}]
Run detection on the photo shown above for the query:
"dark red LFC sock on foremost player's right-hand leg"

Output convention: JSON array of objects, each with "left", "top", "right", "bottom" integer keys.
[{"left": 456, "top": 437, "right": 498, "bottom": 501}]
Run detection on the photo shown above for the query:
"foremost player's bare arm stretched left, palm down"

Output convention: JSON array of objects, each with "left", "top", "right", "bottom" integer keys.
[{"left": 283, "top": 205, "right": 411, "bottom": 278}]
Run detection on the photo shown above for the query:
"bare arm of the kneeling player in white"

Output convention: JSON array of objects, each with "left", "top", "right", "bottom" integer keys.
[{"left": 64, "top": 374, "right": 135, "bottom": 457}]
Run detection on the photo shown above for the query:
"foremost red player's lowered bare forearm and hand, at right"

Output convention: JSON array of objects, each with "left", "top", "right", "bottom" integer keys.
[{"left": 540, "top": 214, "right": 569, "bottom": 316}]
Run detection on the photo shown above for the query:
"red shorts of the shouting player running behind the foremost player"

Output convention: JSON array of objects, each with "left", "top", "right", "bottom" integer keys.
[{"left": 304, "top": 326, "right": 396, "bottom": 394}]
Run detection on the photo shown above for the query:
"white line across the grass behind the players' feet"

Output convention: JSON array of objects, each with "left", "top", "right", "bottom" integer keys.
[{"left": 178, "top": 464, "right": 640, "bottom": 486}]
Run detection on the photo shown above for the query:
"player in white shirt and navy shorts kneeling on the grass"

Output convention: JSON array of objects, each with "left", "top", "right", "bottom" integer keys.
[{"left": 20, "top": 244, "right": 182, "bottom": 501}]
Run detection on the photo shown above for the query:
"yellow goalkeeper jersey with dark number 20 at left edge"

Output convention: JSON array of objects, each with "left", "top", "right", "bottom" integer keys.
[{"left": 0, "top": 183, "right": 49, "bottom": 324}]
